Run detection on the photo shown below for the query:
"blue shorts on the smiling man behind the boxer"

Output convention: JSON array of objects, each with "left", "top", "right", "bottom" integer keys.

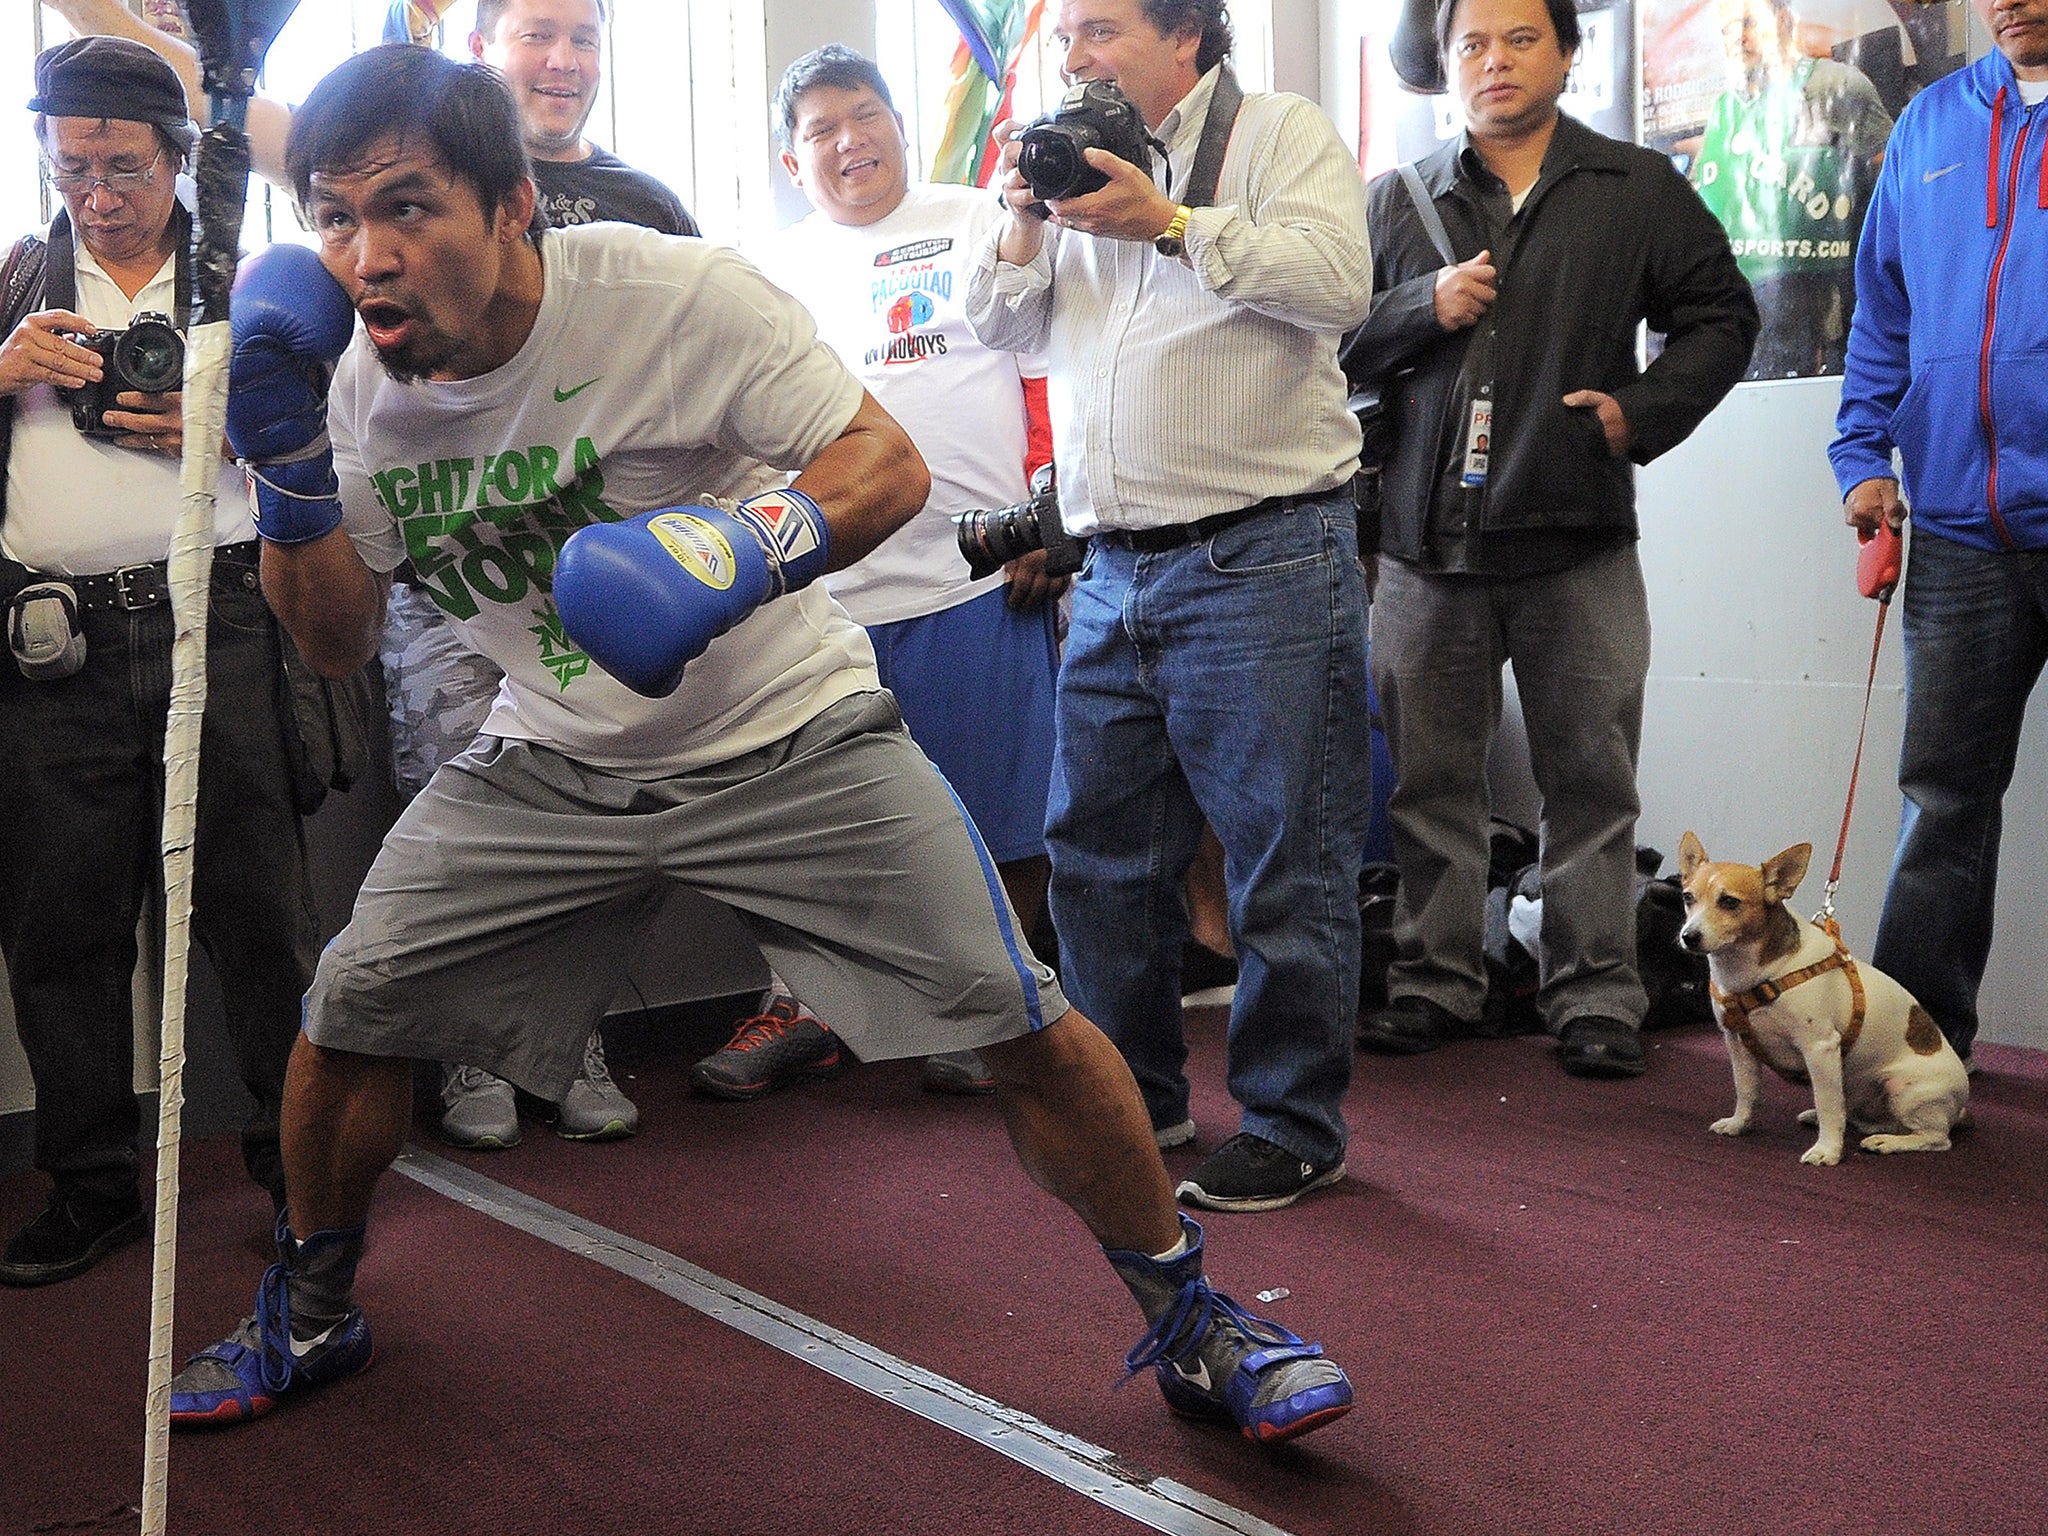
[{"left": 868, "top": 588, "right": 1059, "bottom": 864}]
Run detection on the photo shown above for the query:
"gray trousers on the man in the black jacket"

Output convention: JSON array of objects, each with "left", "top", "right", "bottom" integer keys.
[{"left": 1372, "top": 545, "right": 1651, "bottom": 1032}]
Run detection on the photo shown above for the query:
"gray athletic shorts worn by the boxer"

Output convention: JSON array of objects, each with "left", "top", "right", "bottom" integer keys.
[{"left": 305, "top": 692, "right": 1067, "bottom": 1100}]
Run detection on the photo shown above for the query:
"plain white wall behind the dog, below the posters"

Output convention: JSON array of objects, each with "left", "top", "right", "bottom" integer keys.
[{"left": 1638, "top": 379, "right": 2048, "bottom": 1047}]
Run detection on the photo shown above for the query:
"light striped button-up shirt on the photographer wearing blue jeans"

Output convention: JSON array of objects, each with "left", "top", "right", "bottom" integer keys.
[{"left": 967, "top": 66, "right": 1372, "bottom": 535}]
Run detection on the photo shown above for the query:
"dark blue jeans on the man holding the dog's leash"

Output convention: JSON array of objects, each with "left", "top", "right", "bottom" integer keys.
[{"left": 1870, "top": 530, "right": 2048, "bottom": 1055}]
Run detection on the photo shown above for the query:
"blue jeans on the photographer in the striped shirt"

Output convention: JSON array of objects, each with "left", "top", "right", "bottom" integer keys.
[{"left": 1047, "top": 494, "right": 1372, "bottom": 1163}]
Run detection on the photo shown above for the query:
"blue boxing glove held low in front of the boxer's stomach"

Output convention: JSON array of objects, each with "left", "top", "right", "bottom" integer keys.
[{"left": 555, "top": 492, "right": 827, "bottom": 698}]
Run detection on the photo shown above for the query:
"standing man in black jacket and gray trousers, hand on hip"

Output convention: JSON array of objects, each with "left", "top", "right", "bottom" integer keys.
[{"left": 1346, "top": 0, "right": 1757, "bottom": 1077}]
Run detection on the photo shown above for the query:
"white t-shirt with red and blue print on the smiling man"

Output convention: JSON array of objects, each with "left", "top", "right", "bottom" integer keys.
[{"left": 758, "top": 186, "right": 1044, "bottom": 625}]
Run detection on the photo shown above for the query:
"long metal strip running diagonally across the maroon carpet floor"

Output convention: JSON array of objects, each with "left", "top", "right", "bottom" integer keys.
[{"left": 395, "top": 1147, "right": 1288, "bottom": 1536}]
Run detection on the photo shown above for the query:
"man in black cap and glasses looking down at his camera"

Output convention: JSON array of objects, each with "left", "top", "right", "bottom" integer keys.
[{"left": 0, "top": 37, "right": 317, "bottom": 1286}]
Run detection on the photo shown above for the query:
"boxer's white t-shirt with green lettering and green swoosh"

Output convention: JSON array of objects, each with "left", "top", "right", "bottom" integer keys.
[{"left": 328, "top": 223, "right": 879, "bottom": 778}]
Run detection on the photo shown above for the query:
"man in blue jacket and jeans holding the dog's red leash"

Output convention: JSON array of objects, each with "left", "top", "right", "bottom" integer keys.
[{"left": 1829, "top": 0, "right": 2048, "bottom": 1061}]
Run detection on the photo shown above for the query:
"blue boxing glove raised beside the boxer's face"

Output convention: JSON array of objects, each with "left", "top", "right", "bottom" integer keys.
[{"left": 227, "top": 246, "right": 356, "bottom": 545}]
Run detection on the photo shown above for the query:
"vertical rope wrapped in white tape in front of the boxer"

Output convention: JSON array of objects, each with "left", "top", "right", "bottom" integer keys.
[{"left": 141, "top": 319, "right": 229, "bottom": 1536}]
